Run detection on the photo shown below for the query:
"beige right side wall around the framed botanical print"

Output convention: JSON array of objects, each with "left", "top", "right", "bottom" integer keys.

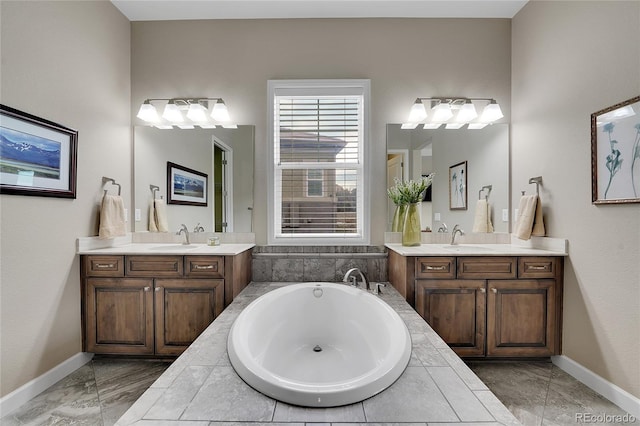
[{"left": 511, "top": 1, "right": 640, "bottom": 397}]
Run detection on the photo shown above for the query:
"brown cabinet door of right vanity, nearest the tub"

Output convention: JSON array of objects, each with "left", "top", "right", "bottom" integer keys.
[{"left": 416, "top": 280, "right": 486, "bottom": 356}]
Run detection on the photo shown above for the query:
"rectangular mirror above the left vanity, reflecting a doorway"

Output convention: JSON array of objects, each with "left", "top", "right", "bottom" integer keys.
[{"left": 132, "top": 125, "right": 254, "bottom": 232}]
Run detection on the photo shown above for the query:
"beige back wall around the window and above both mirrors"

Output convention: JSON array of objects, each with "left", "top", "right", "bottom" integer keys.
[{"left": 131, "top": 19, "right": 511, "bottom": 244}]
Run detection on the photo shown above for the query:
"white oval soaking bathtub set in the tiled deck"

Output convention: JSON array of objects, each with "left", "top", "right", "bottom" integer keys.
[{"left": 227, "top": 283, "right": 411, "bottom": 407}]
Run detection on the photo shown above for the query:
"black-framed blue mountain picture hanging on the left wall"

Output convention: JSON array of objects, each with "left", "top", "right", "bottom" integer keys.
[{"left": 0, "top": 105, "right": 78, "bottom": 198}]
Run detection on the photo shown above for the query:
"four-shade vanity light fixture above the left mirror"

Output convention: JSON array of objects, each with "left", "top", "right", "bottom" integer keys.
[{"left": 137, "top": 98, "right": 237, "bottom": 129}]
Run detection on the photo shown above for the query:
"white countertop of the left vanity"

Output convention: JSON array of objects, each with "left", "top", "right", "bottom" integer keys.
[{"left": 78, "top": 243, "right": 255, "bottom": 256}]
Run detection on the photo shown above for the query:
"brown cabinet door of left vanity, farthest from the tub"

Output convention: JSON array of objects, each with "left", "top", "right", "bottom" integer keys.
[{"left": 85, "top": 278, "right": 153, "bottom": 355}]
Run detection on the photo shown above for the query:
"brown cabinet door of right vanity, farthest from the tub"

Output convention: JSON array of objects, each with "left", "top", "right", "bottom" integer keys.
[{"left": 487, "top": 280, "right": 558, "bottom": 356}]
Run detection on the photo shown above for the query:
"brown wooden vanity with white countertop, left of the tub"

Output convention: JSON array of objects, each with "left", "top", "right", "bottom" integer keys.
[{"left": 80, "top": 244, "right": 253, "bottom": 356}]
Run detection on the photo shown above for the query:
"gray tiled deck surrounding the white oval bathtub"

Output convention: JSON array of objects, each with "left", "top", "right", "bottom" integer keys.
[{"left": 116, "top": 282, "right": 519, "bottom": 426}]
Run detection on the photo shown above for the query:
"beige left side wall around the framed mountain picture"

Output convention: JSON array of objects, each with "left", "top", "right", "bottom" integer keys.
[{"left": 0, "top": 1, "right": 131, "bottom": 395}]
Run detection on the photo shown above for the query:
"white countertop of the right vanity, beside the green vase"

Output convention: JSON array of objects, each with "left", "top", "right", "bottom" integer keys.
[{"left": 385, "top": 243, "right": 568, "bottom": 256}]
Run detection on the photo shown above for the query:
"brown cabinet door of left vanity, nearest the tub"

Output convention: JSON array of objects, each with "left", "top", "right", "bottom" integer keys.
[{"left": 155, "top": 279, "right": 224, "bottom": 355}]
